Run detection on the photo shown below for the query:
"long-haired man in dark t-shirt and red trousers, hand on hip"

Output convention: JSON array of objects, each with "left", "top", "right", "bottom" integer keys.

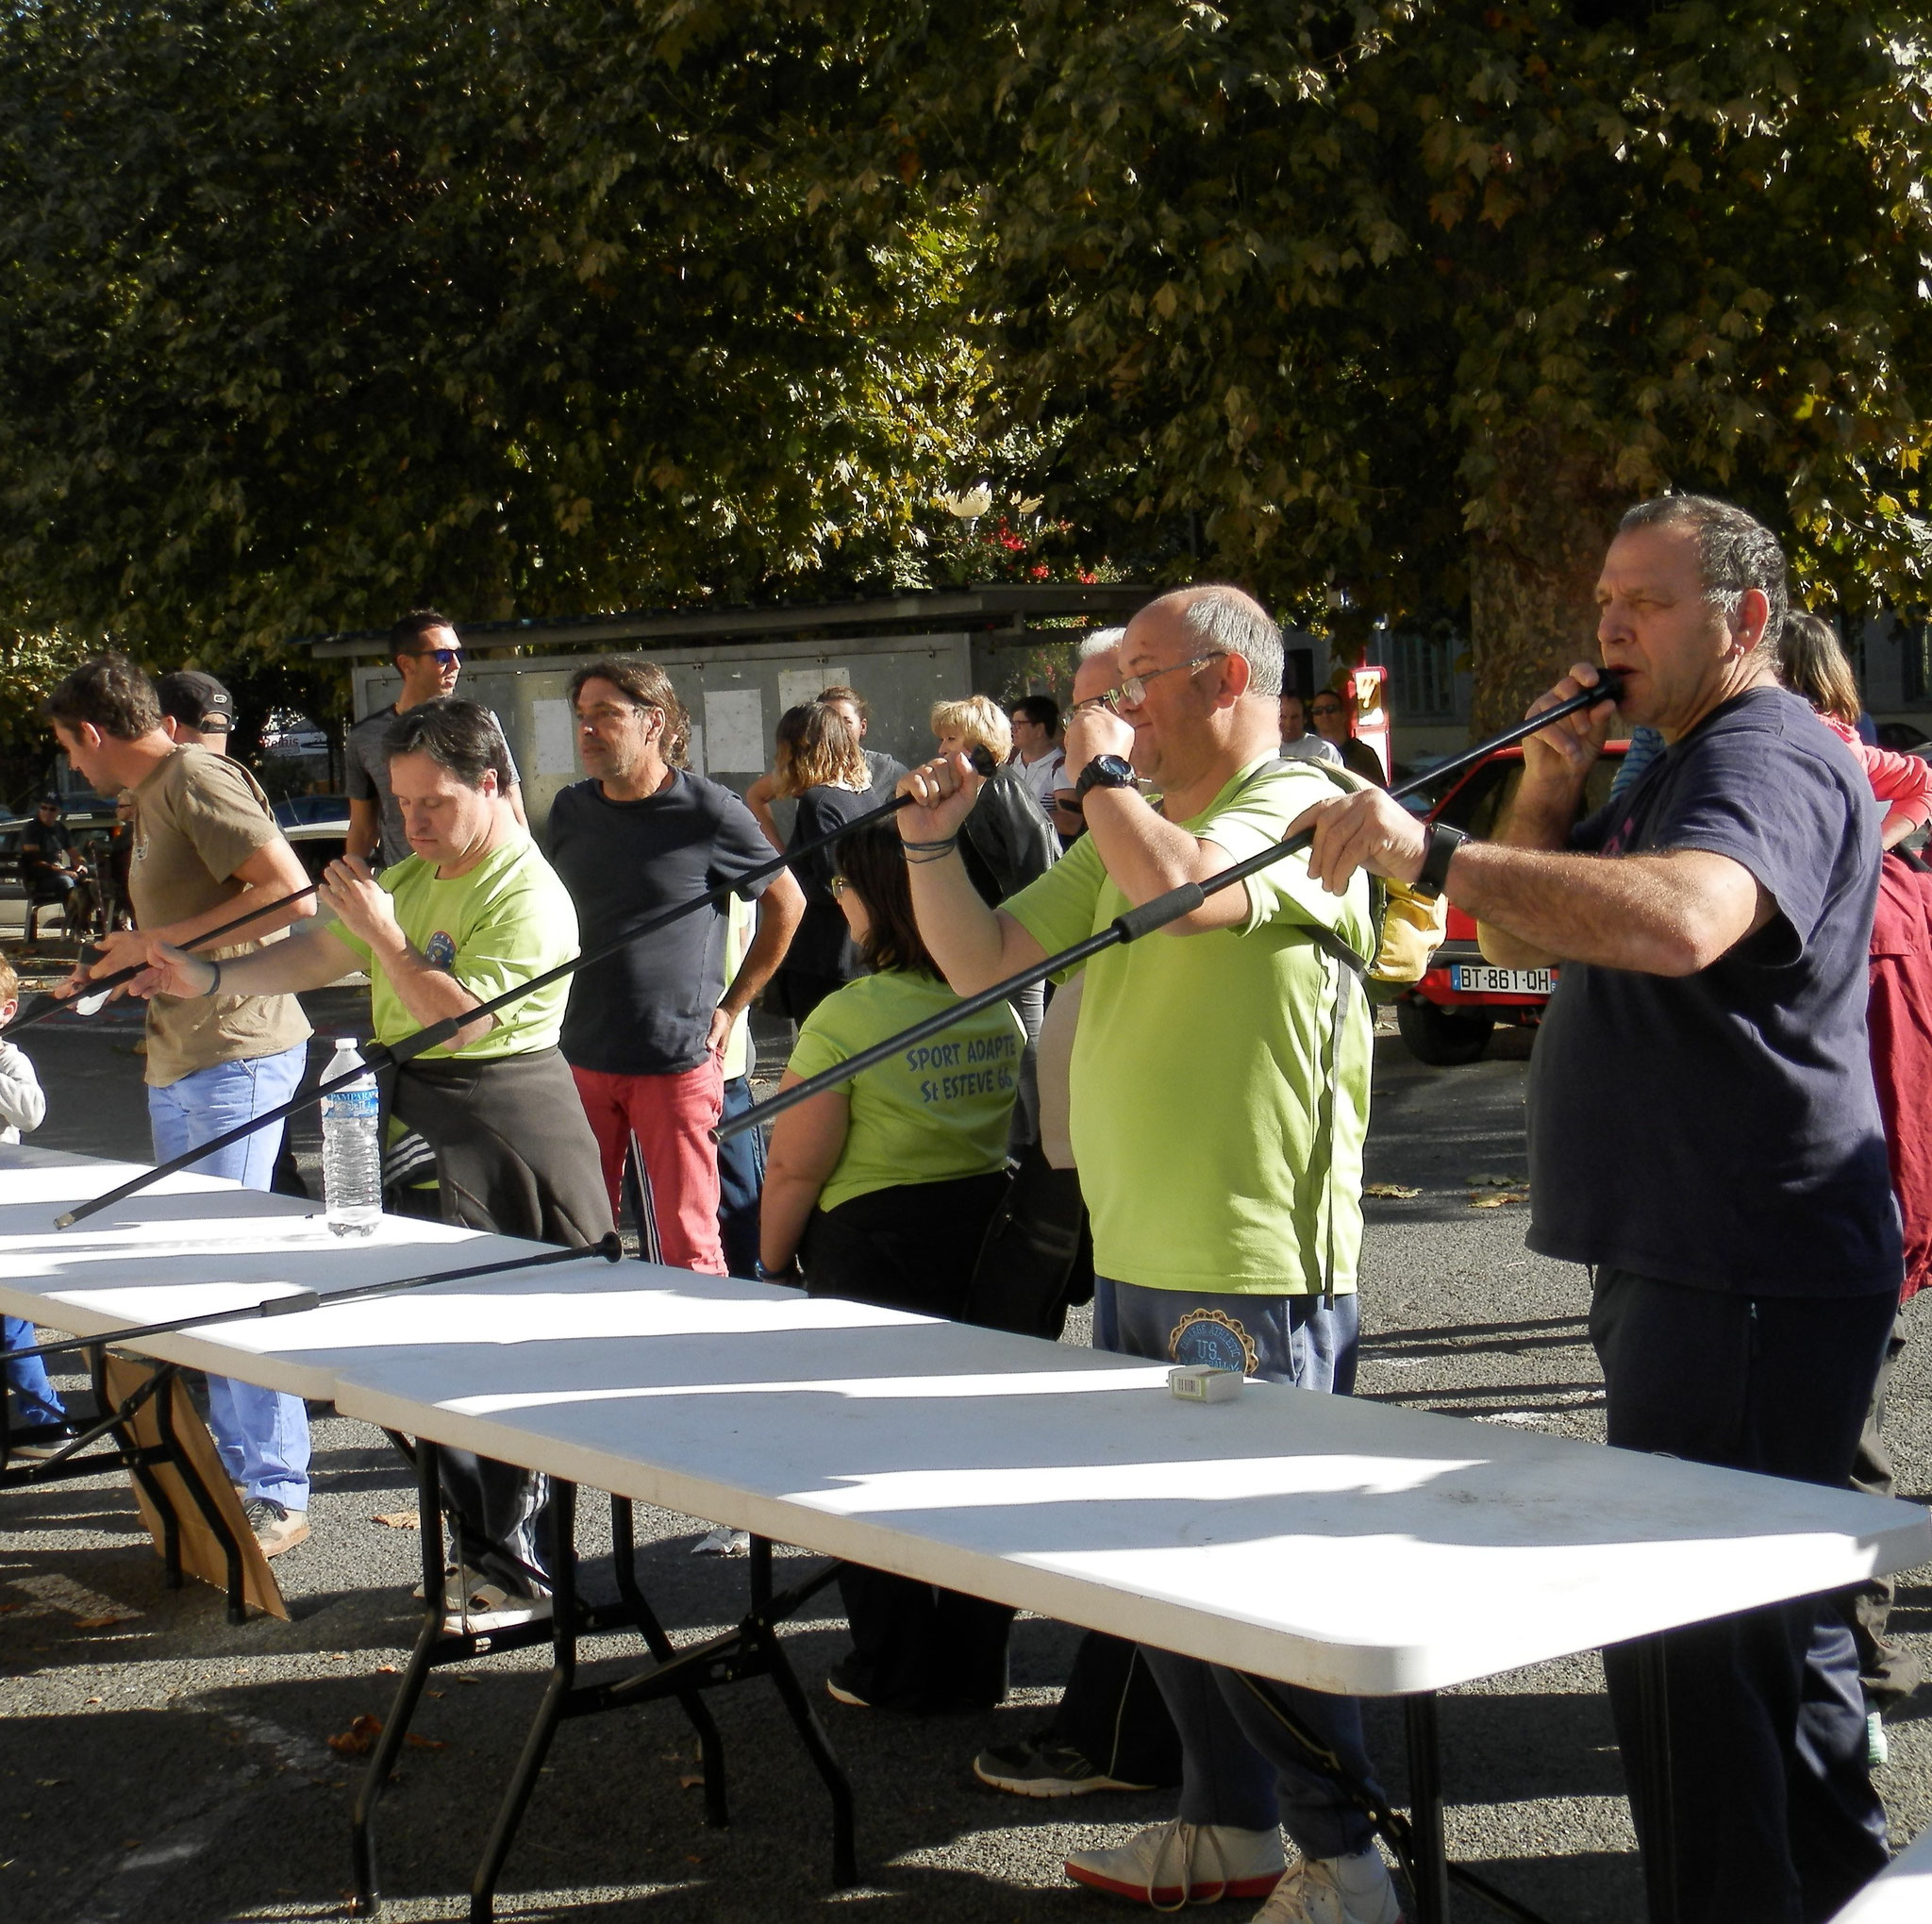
[{"left": 549, "top": 655, "right": 804, "bottom": 1275}]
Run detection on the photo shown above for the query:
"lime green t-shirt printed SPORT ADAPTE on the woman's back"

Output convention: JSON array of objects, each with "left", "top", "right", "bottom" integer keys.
[{"left": 791, "top": 970, "right": 1025, "bottom": 1210}]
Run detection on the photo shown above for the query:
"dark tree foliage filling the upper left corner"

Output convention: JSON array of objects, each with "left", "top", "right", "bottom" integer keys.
[{"left": 0, "top": 0, "right": 983, "bottom": 664}]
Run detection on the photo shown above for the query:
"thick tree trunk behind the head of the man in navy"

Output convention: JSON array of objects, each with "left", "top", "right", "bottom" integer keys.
[{"left": 1468, "top": 428, "right": 1631, "bottom": 740}]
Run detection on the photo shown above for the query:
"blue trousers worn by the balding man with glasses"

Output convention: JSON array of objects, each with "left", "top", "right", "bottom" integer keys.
[{"left": 1093, "top": 1277, "right": 1381, "bottom": 1856}]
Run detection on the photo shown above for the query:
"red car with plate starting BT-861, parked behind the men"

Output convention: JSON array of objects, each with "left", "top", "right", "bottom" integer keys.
[{"left": 1395, "top": 742, "right": 1631, "bottom": 1066}]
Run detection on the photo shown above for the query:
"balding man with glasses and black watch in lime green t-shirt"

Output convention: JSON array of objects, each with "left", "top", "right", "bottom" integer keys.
[{"left": 898, "top": 587, "right": 1399, "bottom": 1924}]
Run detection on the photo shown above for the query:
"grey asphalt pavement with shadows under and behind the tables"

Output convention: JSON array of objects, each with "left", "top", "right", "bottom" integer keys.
[{"left": 0, "top": 991, "right": 1932, "bottom": 1924}]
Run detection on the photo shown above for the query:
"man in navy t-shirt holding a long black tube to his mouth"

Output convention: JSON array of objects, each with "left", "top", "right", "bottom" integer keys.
[{"left": 1307, "top": 494, "right": 1903, "bottom": 1924}]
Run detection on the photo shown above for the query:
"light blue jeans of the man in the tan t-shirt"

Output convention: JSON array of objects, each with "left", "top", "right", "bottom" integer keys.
[{"left": 147, "top": 1043, "right": 309, "bottom": 1511}]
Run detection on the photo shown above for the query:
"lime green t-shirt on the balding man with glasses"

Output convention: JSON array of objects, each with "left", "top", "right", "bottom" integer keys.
[{"left": 1003, "top": 757, "right": 1374, "bottom": 1297}]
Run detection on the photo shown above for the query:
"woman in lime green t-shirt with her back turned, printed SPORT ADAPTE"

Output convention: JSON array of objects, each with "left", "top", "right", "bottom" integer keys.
[{"left": 759, "top": 823, "right": 1024, "bottom": 1712}]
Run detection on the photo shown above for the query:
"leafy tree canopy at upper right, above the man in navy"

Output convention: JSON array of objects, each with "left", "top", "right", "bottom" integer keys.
[{"left": 842, "top": 0, "right": 1932, "bottom": 721}]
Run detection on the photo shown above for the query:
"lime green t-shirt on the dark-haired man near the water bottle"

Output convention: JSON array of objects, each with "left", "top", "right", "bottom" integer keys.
[{"left": 330, "top": 832, "right": 577, "bottom": 1062}]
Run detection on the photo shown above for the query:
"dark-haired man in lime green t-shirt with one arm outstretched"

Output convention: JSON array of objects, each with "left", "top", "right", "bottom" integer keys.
[{"left": 131, "top": 701, "right": 612, "bottom": 1632}]
